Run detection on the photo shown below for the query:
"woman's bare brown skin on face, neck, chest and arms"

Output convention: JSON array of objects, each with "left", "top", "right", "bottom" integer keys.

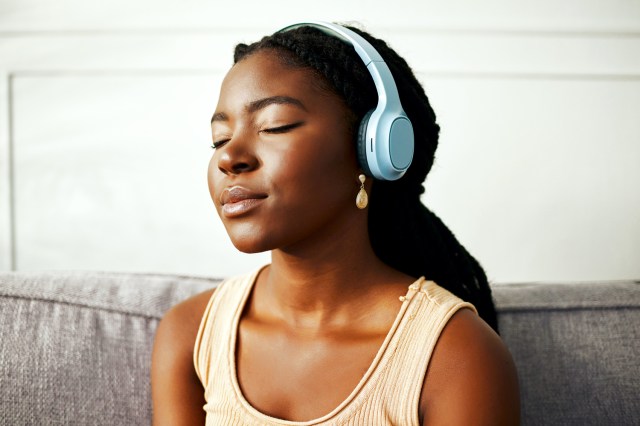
[{"left": 152, "top": 51, "right": 519, "bottom": 425}]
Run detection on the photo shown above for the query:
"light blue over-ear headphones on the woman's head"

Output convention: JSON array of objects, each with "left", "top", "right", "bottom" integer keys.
[{"left": 278, "top": 21, "right": 414, "bottom": 180}]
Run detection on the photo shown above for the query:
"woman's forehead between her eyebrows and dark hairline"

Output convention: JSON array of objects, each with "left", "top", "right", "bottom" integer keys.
[{"left": 218, "top": 50, "right": 330, "bottom": 107}]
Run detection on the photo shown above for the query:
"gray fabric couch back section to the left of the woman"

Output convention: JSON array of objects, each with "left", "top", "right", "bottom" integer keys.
[{"left": 0, "top": 272, "right": 218, "bottom": 425}]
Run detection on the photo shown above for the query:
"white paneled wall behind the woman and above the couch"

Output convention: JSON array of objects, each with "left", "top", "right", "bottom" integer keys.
[{"left": 0, "top": 0, "right": 640, "bottom": 282}]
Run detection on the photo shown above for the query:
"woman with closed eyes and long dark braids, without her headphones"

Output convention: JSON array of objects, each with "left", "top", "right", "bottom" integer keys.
[{"left": 152, "top": 21, "right": 519, "bottom": 425}]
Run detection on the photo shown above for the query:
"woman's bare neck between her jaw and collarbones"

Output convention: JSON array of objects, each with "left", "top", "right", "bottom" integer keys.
[{"left": 254, "top": 221, "right": 411, "bottom": 331}]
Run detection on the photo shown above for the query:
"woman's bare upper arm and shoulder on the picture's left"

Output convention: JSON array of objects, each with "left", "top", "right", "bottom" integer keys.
[{"left": 151, "top": 290, "right": 212, "bottom": 426}]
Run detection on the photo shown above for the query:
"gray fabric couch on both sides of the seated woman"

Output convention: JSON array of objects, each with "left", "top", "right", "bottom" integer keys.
[{"left": 0, "top": 272, "right": 640, "bottom": 425}]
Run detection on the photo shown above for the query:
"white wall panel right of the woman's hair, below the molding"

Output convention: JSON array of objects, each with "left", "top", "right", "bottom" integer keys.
[{"left": 423, "top": 75, "right": 640, "bottom": 281}]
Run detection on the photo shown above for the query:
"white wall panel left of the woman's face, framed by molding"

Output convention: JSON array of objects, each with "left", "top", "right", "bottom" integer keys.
[{"left": 14, "top": 74, "right": 270, "bottom": 275}]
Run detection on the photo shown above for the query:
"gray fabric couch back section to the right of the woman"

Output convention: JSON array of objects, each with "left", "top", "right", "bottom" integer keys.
[{"left": 493, "top": 282, "right": 640, "bottom": 425}]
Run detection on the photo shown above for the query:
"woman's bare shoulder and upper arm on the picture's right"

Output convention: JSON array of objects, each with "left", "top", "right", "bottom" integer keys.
[{"left": 420, "top": 309, "right": 520, "bottom": 425}]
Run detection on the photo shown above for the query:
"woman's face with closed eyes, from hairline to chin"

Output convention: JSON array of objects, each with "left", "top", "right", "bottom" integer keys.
[{"left": 208, "top": 50, "right": 366, "bottom": 253}]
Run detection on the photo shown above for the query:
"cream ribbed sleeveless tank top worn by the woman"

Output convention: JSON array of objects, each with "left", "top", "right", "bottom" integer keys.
[{"left": 194, "top": 271, "right": 476, "bottom": 426}]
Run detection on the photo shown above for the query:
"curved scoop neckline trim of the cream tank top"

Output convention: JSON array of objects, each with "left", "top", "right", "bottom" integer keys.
[{"left": 227, "top": 265, "right": 426, "bottom": 426}]
